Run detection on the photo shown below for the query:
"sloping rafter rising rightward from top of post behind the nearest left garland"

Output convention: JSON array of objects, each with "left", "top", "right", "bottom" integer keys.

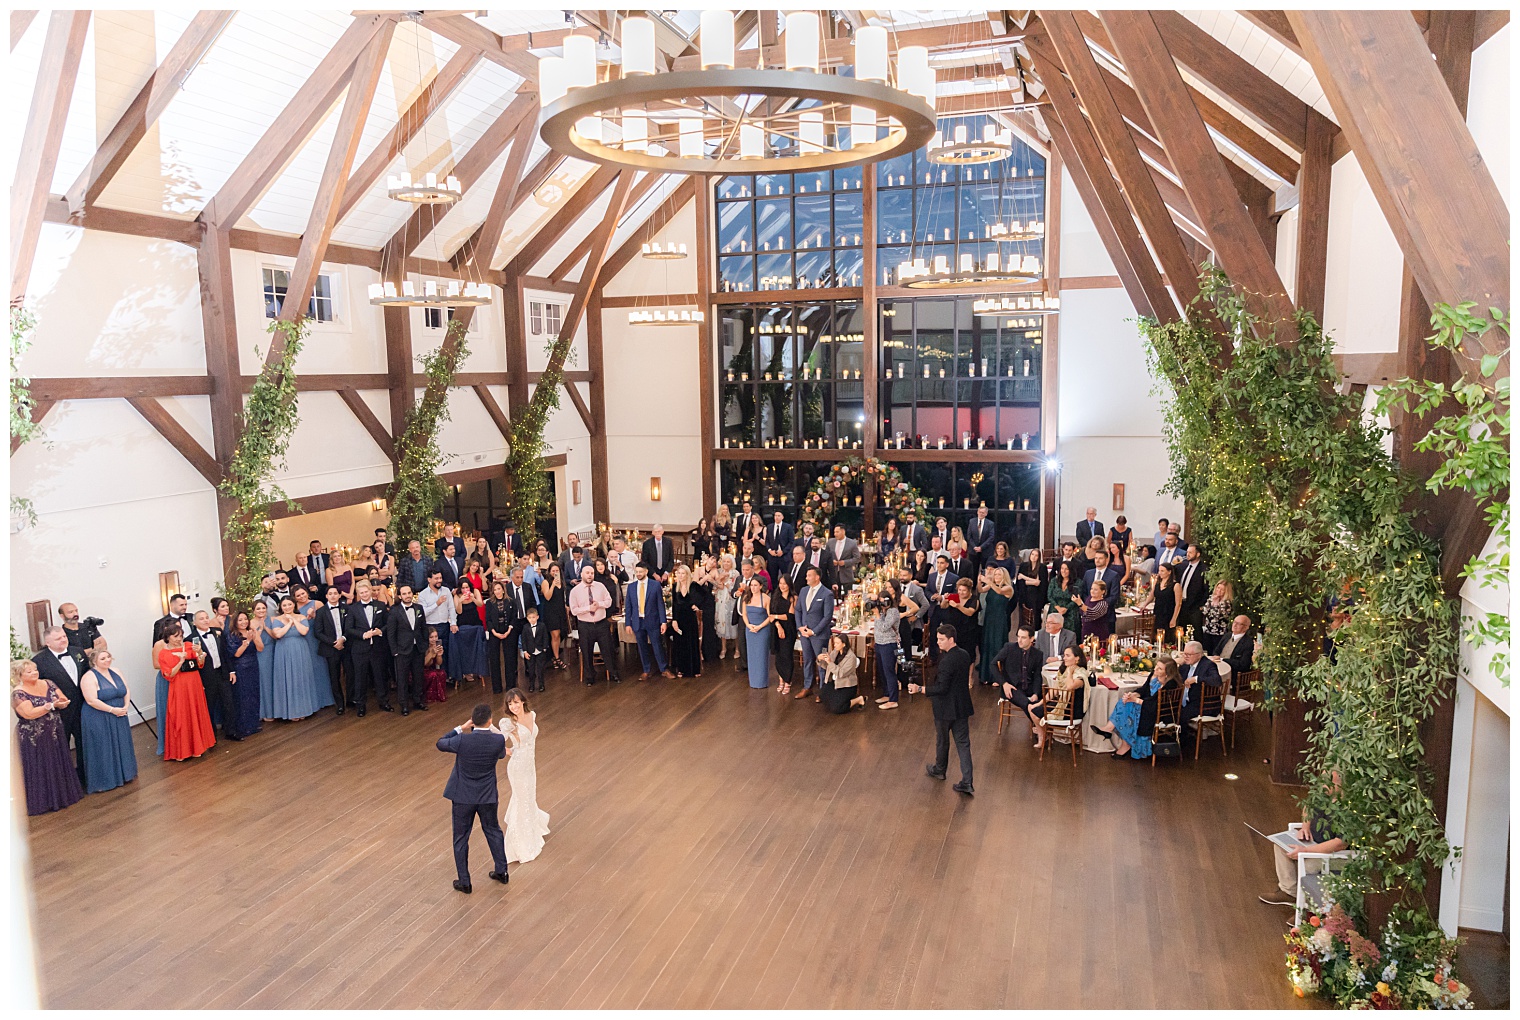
[{"left": 199, "top": 14, "right": 395, "bottom": 226}]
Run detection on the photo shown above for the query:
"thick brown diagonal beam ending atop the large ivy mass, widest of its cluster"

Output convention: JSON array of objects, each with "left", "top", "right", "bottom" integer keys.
[{"left": 1102, "top": 11, "right": 1298, "bottom": 341}]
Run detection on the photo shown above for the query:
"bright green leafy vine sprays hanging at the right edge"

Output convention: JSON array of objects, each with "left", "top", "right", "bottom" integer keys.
[{"left": 1377, "top": 301, "right": 1509, "bottom": 687}]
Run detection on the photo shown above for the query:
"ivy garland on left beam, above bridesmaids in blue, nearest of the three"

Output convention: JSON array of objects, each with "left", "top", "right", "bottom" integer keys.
[{"left": 217, "top": 318, "right": 310, "bottom": 610}]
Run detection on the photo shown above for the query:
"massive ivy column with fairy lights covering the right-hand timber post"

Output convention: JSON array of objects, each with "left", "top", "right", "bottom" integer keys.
[{"left": 1140, "top": 268, "right": 1458, "bottom": 926}]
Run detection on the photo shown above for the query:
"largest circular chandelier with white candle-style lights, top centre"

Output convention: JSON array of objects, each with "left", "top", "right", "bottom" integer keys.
[{"left": 538, "top": 11, "right": 935, "bottom": 173}]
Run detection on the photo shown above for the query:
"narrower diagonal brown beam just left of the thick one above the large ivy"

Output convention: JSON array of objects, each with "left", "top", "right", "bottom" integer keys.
[{"left": 1024, "top": 11, "right": 1197, "bottom": 309}]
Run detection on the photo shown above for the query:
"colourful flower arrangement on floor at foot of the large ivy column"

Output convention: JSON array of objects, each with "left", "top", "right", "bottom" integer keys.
[{"left": 1283, "top": 906, "right": 1473, "bottom": 1009}]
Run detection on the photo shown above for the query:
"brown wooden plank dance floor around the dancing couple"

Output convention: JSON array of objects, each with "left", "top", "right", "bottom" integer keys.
[{"left": 30, "top": 661, "right": 1304, "bottom": 1009}]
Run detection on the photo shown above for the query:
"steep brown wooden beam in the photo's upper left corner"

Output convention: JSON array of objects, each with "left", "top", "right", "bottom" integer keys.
[{"left": 11, "top": 11, "right": 90, "bottom": 304}]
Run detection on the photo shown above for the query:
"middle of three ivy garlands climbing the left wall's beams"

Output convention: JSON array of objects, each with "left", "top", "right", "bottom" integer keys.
[{"left": 386, "top": 319, "right": 470, "bottom": 549}]
